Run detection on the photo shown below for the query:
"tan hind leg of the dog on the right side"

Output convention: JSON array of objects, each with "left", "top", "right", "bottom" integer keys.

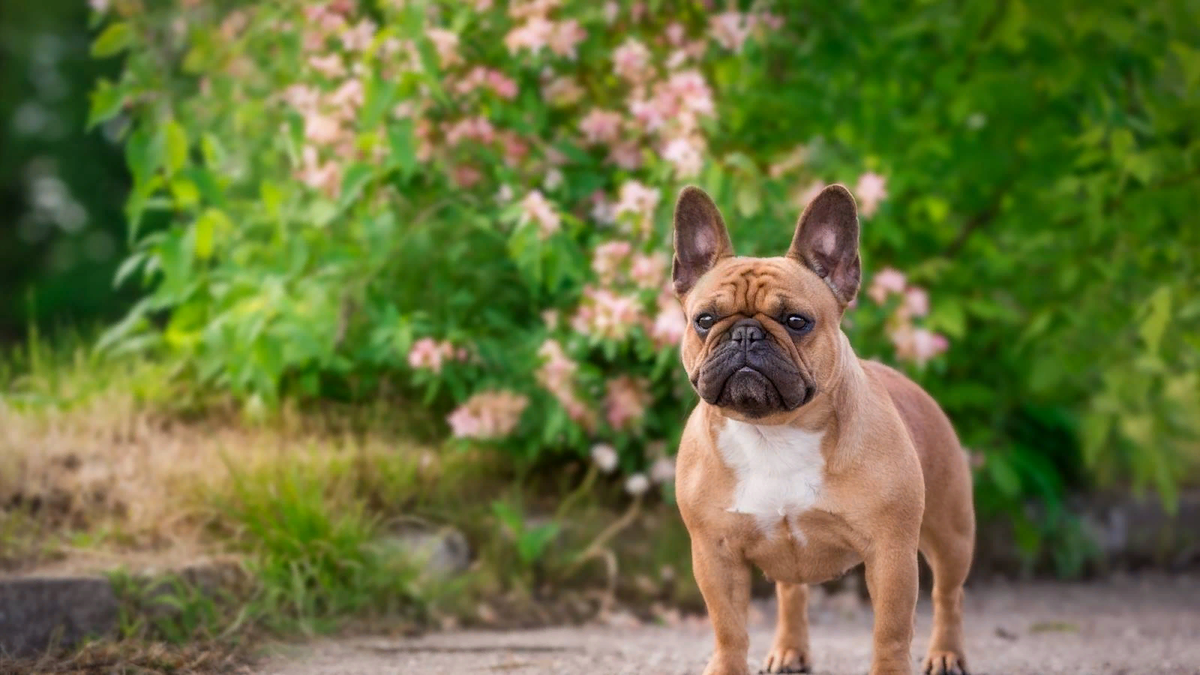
[{"left": 920, "top": 502, "right": 974, "bottom": 675}]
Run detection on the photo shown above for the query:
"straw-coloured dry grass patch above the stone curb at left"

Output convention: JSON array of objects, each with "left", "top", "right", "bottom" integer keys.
[{"left": 0, "top": 367, "right": 445, "bottom": 571}]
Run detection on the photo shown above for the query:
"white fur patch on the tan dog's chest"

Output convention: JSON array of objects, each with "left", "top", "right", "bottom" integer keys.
[{"left": 716, "top": 419, "right": 824, "bottom": 533}]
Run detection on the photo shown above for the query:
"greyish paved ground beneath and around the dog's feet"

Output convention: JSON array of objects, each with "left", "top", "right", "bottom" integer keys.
[{"left": 258, "top": 575, "right": 1200, "bottom": 675}]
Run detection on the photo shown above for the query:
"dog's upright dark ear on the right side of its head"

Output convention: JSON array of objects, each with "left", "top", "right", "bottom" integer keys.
[{"left": 787, "top": 185, "right": 863, "bottom": 302}]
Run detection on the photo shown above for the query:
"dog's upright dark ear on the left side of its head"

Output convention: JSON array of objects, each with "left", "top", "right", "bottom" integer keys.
[{"left": 671, "top": 186, "right": 733, "bottom": 298}]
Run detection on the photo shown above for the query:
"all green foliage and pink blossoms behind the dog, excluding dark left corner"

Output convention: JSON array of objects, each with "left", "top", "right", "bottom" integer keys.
[{"left": 91, "top": 0, "right": 1200, "bottom": 540}]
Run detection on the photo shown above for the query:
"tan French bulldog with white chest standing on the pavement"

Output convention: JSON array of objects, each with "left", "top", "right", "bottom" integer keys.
[{"left": 672, "top": 185, "right": 974, "bottom": 675}]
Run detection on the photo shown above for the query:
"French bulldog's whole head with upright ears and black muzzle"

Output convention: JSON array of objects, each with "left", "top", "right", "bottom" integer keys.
[{"left": 672, "top": 185, "right": 862, "bottom": 424}]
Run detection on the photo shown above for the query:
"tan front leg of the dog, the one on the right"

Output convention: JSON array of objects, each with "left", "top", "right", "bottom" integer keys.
[{"left": 866, "top": 542, "right": 918, "bottom": 675}]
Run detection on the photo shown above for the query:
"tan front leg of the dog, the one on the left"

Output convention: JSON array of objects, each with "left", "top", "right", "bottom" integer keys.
[{"left": 691, "top": 539, "right": 750, "bottom": 675}]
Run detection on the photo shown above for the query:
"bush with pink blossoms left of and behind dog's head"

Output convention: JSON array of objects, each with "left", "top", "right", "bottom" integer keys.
[{"left": 87, "top": 0, "right": 947, "bottom": 489}]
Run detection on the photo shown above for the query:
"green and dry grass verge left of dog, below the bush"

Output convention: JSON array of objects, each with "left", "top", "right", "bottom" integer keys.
[{"left": 0, "top": 326, "right": 698, "bottom": 671}]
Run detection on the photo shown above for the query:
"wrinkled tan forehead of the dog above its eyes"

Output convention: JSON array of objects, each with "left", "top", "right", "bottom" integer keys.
[{"left": 688, "top": 258, "right": 836, "bottom": 315}]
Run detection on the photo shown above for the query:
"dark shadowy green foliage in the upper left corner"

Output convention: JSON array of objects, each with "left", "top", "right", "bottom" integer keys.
[{"left": 0, "top": 0, "right": 137, "bottom": 341}]
